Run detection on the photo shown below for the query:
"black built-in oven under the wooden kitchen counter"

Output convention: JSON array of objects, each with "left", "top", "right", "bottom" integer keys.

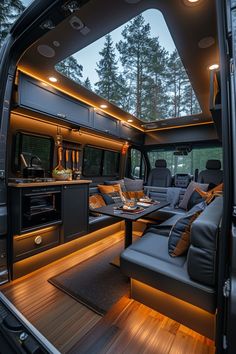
[{"left": 20, "top": 186, "right": 61, "bottom": 232}]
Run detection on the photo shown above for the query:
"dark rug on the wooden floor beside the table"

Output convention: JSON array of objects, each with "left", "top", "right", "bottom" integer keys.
[{"left": 48, "top": 240, "right": 130, "bottom": 315}]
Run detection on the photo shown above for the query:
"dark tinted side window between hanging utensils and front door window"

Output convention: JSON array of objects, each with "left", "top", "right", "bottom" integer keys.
[{"left": 83, "top": 146, "right": 120, "bottom": 177}]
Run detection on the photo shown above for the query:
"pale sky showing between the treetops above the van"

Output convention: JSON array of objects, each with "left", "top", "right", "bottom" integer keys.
[{"left": 22, "top": 0, "right": 175, "bottom": 84}]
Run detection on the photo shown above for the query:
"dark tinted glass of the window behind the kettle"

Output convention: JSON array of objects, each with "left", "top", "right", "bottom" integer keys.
[{"left": 14, "top": 133, "right": 53, "bottom": 175}]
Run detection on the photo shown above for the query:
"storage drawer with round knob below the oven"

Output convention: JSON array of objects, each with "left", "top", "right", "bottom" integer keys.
[{"left": 13, "top": 228, "right": 60, "bottom": 261}]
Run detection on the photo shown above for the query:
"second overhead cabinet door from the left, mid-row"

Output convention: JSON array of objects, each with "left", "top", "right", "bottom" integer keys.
[{"left": 94, "top": 111, "right": 119, "bottom": 136}]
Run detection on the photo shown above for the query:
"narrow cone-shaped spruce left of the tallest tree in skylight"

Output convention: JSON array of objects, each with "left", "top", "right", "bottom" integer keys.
[{"left": 95, "top": 34, "right": 124, "bottom": 105}]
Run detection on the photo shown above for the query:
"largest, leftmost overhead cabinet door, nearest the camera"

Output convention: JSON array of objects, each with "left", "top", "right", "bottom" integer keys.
[{"left": 19, "top": 74, "right": 92, "bottom": 127}]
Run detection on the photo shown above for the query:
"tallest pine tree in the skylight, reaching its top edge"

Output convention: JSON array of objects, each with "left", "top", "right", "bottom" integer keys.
[{"left": 117, "top": 15, "right": 153, "bottom": 118}]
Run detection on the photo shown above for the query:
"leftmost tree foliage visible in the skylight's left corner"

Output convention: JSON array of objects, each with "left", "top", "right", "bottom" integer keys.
[{"left": 56, "top": 56, "right": 83, "bottom": 84}]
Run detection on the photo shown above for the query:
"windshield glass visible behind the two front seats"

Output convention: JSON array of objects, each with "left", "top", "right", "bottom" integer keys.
[{"left": 148, "top": 147, "right": 222, "bottom": 175}]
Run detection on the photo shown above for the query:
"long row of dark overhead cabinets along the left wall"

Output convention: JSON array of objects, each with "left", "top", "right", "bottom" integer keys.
[{"left": 18, "top": 73, "right": 144, "bottom": 145}]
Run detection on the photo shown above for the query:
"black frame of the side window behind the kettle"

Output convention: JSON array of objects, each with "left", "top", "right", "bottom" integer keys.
[{"left": 12, "top": 130, "right": 55, "bottom": 175}]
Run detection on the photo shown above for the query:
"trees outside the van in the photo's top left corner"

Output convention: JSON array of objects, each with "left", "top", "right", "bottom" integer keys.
[{"left": 0, "top": 0, "right": 25, "bottom": 47}]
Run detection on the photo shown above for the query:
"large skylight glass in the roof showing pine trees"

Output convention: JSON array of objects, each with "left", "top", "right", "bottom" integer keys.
[{"left": 56, "top": 9, "right": 201, "bottom": 122}]
